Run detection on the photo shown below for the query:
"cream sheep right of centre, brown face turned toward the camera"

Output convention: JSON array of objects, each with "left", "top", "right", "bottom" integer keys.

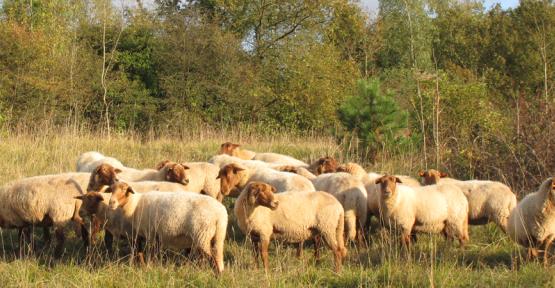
[{"left": 376, "top": 175, "right": 469, "bottom": 249}]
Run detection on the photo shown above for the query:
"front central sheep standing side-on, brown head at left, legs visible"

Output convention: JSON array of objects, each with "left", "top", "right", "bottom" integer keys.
[{"left": 233, "top": 182, "right": 347, "bottom": 272}]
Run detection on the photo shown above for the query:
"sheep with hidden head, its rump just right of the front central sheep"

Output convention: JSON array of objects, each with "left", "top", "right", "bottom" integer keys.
[{"left": 311, "top": 173, "right": 368, "bottom": 245}]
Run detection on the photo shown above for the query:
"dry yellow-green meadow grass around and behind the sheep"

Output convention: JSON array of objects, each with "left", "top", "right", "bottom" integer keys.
[{"left": 0, "top": 130, "right": 555, "bottom": 287}]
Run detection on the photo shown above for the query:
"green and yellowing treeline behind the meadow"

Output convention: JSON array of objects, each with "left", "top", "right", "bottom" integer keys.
[{"left": 0, "top": 0, "right": 555, "bottom": 188}]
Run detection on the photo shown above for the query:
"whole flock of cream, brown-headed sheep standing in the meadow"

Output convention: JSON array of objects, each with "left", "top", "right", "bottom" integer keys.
[{"left": 0, "top": 142, "right": 555, "bottom": 273}]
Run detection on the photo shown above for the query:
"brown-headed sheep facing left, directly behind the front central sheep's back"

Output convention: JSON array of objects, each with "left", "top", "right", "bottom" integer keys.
[{"left": 217, "top": 164, "right": 315, "bottom": 197}]
